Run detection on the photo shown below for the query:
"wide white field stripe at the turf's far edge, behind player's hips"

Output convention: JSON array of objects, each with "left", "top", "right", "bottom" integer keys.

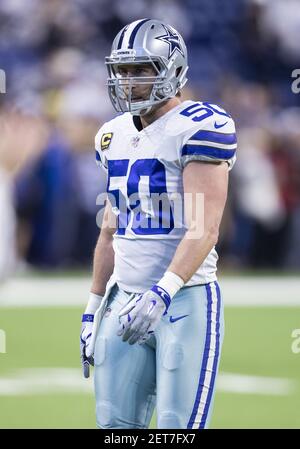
[{"left": 0, "top": 276, "right": 300, "bottom": 307}]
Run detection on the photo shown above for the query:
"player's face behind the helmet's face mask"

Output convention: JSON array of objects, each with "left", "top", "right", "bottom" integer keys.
[{"left": 117, "top": 64, "right": 157, "bottom": 102}]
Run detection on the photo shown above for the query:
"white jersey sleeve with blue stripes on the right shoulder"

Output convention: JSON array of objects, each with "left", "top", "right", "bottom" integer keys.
[{"left": 181, "top": 110, "right": 237, "bottom": 170}]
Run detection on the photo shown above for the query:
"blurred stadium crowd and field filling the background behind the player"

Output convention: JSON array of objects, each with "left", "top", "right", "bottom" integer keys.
[{"left": 0, "top": 0, "right": 300, "bottom": 428}]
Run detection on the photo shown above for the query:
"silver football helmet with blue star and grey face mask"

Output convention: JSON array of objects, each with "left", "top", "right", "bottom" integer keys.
[{"left": 105, "top": 19, "right": 188, "bottom": 115}]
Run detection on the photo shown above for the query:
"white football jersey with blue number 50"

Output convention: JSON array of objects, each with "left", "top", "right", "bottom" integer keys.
[{"left": 95, "top": 101, "right": 237, "bottom": 292}]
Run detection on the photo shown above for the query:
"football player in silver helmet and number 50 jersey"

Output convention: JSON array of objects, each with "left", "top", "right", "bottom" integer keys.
[{"left": 81, "top": 19, "right": 237, "bottom": 429}]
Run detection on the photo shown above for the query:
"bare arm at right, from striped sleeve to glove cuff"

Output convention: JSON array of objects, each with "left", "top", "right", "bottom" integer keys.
[{"left": 168, "top": 162, "right": 228, "bottom": 283}]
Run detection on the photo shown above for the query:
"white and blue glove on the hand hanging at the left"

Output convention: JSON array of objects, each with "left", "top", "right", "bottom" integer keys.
[{"left": 80, "top": 293, "right": 102, "bottom": 379}]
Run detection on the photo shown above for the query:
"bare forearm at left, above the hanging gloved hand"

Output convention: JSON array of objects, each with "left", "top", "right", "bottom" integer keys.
[{"left": 91, "top": 232, "right": 115, "bottom": 296}]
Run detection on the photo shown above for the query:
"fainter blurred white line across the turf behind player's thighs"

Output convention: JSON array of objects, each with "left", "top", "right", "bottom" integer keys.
[{"left": 0, "top": 368, "right": 298, "bottom": 396}]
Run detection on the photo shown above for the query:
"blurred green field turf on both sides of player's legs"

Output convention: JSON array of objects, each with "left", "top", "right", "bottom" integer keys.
[{"left": 0, "top": 307, "right": 300, "bottom": 428}]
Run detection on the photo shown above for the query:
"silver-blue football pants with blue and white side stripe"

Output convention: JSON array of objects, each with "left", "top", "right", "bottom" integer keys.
[{"left": 94, "top": 282, "right": 224, "bottom": 429}]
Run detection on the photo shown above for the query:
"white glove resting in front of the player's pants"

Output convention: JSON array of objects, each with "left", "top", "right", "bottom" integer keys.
[{"left": 118, "top": 271, "right": 184, "bottom": 345}]
